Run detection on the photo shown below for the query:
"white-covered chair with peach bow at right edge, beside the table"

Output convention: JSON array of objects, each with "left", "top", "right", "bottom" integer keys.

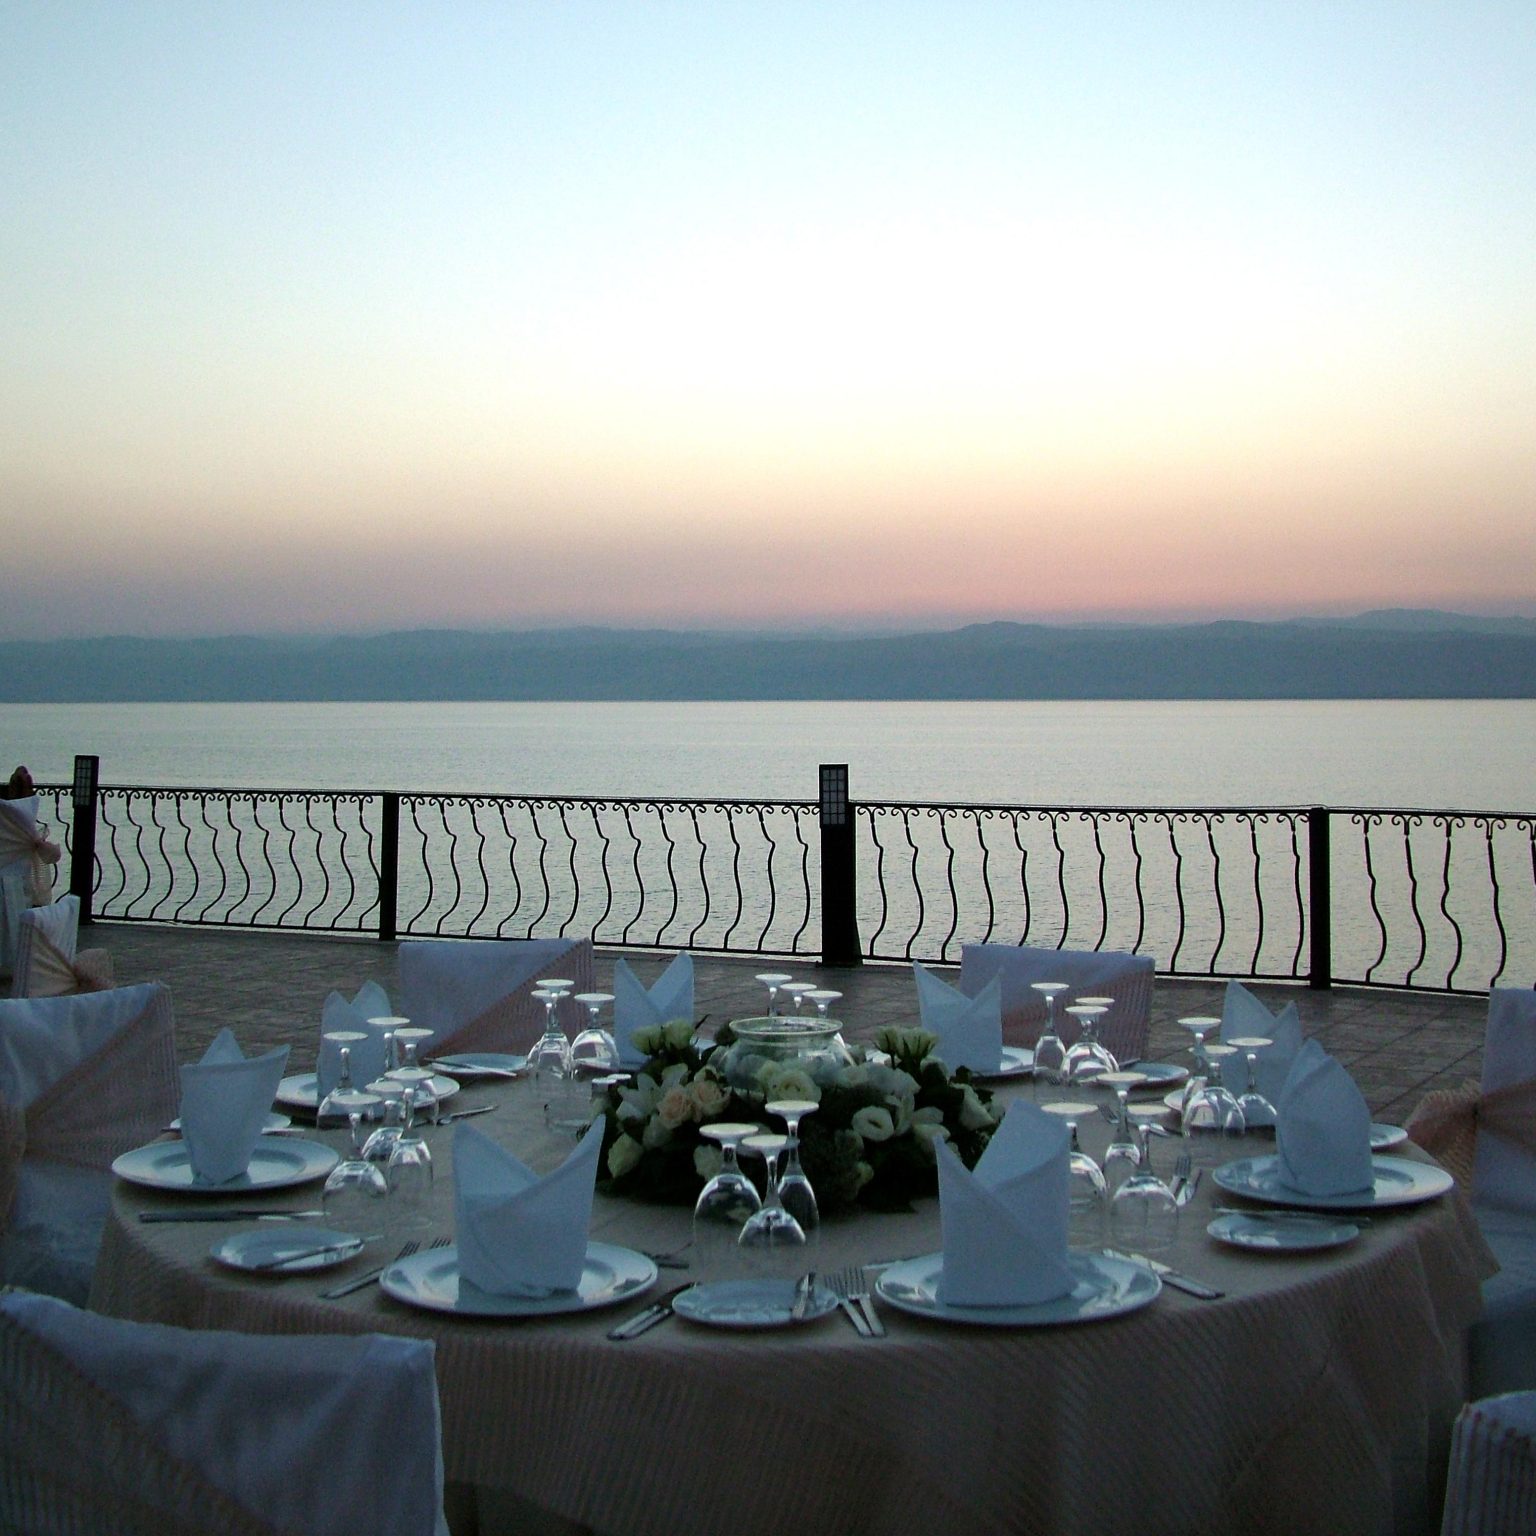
[{"left": 1409, "top": 988, "right": 1536, "bottom": 1398}]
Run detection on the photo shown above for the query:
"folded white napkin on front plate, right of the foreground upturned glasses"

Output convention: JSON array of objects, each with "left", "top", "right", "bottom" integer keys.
[{"left": 938, "top": 1100, "right": 1072, "bottom": 1307}]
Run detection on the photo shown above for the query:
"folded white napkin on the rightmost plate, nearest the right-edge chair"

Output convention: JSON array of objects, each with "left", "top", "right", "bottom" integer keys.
[{"left": 1275, "top": 1040, "right": 1375, "bottom": 1195}]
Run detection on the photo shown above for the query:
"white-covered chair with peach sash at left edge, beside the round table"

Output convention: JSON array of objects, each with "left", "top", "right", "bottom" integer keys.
[{"left": 0, "top": 982, "right": 178, "bottom": 1303}]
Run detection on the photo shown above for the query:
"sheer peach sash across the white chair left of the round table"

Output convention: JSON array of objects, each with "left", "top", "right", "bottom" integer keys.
[{"left": 0, "top": 988, "right": 178, "bottom": 1233}]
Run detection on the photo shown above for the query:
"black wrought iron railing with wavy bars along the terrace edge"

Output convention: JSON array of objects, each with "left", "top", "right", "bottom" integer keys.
[{"left": 27, "top": 759, "right": 1536, "bottom": 992}]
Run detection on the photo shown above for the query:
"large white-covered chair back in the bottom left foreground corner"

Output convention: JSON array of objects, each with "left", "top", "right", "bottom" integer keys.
[{"left": 0, "top": 1292, "right": 449, "bottom": 1536}]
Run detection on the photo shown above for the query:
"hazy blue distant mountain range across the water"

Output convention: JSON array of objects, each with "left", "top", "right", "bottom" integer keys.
[{"left": 0, "top": 608, "right": 1536, "bottom": 703}]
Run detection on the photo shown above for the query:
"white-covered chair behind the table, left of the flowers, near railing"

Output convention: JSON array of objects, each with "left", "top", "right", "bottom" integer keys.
[{"left": 398, "top": 938, "right": 598, "bottom": 1058}]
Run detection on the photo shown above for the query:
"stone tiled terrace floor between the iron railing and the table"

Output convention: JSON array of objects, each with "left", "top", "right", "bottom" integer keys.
[{"left": 92, "top": 923, "right": 1487, "bottom": 1123}]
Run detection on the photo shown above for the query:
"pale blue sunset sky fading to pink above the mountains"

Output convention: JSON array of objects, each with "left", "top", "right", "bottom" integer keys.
[{"left": 0, "top": 0, "right": 1536, "bottom": 639}]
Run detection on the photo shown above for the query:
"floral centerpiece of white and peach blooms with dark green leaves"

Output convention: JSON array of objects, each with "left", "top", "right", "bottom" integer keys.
[{"left": 601, "top": 1018, "right": 998, "bottom": 1210}]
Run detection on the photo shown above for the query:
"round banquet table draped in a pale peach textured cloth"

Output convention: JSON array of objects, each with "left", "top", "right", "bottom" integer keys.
[{"left": 92, "top": 1083, "right": 1485, "bottom": 1536}]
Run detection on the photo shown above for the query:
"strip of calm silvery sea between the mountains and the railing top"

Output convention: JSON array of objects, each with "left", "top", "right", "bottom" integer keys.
[{"left": 0, "top": 699, "right": 1536, "bottom": 813}]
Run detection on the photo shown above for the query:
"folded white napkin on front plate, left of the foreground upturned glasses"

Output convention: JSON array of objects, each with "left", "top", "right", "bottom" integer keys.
[{"left": 453, "top": 1120, "right": 602, "bottom": 1296}]
